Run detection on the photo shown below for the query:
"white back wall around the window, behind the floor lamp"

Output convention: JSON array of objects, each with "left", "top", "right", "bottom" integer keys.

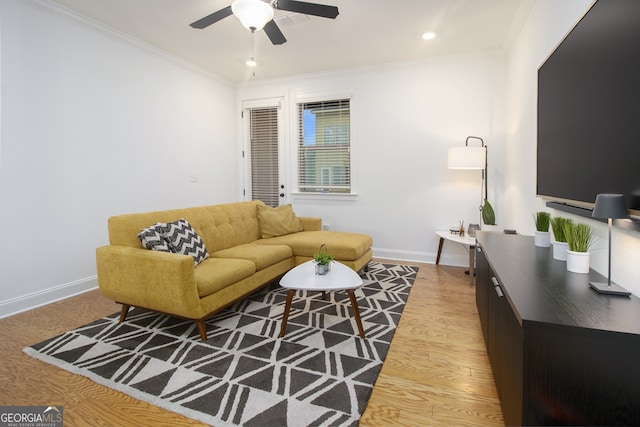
[{"left": 238, "top": 52, "right": 505, "bottom": 265}]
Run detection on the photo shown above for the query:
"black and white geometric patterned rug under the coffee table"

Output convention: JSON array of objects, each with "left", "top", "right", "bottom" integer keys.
[{"left": 24, "top": 262, "right": 418, "bottom": 427}]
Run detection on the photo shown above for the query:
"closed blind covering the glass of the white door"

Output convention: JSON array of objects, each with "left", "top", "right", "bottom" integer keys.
[{"left": 247, "top": 107, "right": 280, "bottom": 207}]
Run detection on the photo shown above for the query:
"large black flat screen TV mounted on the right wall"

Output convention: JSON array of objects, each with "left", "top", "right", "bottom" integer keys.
[{"left": 536, "top": 0, "right": 640, "bottom": 215}]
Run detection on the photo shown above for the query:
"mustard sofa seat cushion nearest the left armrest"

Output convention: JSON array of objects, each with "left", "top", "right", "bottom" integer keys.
[{"left": 194, "top": 257, "right": 256, "bottom": 298}]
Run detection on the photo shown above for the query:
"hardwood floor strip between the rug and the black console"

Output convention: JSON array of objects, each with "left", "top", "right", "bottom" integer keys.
[{"left": 360, "top": 263, "right": 504, "bottom": 426}]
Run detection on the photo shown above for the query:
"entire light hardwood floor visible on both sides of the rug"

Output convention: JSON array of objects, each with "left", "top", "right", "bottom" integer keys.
[{"left": 0, "top": 261, "right": 504, "bottom": 427}]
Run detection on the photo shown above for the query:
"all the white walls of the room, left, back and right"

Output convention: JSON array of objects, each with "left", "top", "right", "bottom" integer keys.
[{"left": 5, "top": 0, "right": 640, "bottom": 317}]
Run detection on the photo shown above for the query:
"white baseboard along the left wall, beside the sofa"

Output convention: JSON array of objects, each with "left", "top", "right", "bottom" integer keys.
[{"left": 0, "top": 276, "right": 98, "bottom": 319}]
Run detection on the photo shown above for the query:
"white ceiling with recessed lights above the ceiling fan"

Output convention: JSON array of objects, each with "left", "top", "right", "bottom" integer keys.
[{"left": 52, "top": 0, "right": 533, "bottom": 82}]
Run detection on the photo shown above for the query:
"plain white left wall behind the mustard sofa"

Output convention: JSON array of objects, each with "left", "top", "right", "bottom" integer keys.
[{"left": 0, "top": 0, "right": 237, "bottom": 317}]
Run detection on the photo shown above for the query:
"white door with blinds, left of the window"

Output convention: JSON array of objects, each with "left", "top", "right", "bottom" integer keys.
[{"left": 242, "top": 99, "right": 286, "bottom": 207}]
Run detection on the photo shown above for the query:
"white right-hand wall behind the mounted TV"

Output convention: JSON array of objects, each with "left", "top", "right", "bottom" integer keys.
[{"left": 504, "top": 0, "right": 640, "bottom": 296}]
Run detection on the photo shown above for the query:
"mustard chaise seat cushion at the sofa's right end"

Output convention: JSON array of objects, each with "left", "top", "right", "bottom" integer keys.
[{"left": 256, "top": 231, "right": 373, "bottom": 261}]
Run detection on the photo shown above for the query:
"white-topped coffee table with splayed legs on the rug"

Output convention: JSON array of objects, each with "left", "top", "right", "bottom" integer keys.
[{"left": 280, "top": 261, "right": 364, "bottom": 338}]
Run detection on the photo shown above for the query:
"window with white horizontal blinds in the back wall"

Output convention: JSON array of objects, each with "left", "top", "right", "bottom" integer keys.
[{"left": 298, "top": 99, "right": 351, "bottom": 193}]
